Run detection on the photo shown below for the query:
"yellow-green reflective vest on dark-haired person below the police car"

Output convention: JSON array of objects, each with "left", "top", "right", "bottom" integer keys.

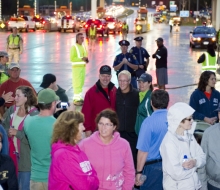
[{"left": 202, "top": 52, "right": 217, "bottom": 72}]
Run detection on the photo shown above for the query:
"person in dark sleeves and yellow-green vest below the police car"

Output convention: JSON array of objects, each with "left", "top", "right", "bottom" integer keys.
[{"left": 197, "top": 44, "right": 217, "bottom": 72}]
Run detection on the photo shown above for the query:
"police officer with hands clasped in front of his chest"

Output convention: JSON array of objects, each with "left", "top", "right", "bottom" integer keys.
[{"left": 113, "top": 40, "right": 139, "bottom": 88}]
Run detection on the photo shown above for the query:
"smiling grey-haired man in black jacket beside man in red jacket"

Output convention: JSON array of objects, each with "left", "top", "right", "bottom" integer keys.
[{"left": 116, "top": 70, "right": 139, "bottom": 166}]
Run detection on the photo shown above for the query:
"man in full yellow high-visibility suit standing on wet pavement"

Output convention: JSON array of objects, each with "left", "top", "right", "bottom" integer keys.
[{"left": 70, "top": 33, "right": 89, "bottom": 106}]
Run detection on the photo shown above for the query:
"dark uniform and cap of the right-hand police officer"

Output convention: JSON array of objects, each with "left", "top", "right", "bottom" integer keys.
[{"left": 129, "top": 36, "right": 150, "bottom": 70}]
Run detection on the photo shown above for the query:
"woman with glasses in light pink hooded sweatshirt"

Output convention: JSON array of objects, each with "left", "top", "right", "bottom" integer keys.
[{"left": 79, "top": 109, "right": 135, "bottom": 190}]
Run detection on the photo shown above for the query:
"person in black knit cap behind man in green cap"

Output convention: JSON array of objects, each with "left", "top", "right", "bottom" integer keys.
[{"left": 40, "top": 73, "right": 69, "bottom": 102}]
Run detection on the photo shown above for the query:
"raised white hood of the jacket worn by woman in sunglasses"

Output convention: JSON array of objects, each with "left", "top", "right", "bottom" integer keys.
[{"left": 167, "top": 102, "right": 196, "bottom": 137}]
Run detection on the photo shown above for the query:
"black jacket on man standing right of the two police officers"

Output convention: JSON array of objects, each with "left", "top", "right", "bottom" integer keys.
[{"left": 152, "top": 45, "right": 167, "bottom": 69}]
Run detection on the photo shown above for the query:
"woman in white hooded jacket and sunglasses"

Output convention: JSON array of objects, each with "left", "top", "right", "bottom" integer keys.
[{"left": 160, "top": 102, "right": 206, "bottom": 190}]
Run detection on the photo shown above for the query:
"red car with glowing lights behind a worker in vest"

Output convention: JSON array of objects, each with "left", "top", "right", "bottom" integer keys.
[{"left": 85, "top": 19, "right": 109, "bottom": 37}]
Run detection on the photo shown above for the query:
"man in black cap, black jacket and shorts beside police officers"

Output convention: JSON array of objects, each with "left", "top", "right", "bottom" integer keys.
[{"left": 152, "top": 38, "right": 168, "bottom": 90}]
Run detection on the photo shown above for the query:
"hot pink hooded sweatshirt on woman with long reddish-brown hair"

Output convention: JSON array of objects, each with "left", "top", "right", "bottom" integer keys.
[{"left": 48, "top": 141, "right": 99, "bottom": 190}]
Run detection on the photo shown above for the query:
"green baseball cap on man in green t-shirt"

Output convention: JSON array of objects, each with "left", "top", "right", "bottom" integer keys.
[{"left": 37, "top": 88, "right": 60, "bottom": 104}]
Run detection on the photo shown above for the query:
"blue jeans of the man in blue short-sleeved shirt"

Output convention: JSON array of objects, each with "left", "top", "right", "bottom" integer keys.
[{"left": 140, "top": 162, "right": 163, "bottom": 190}]
